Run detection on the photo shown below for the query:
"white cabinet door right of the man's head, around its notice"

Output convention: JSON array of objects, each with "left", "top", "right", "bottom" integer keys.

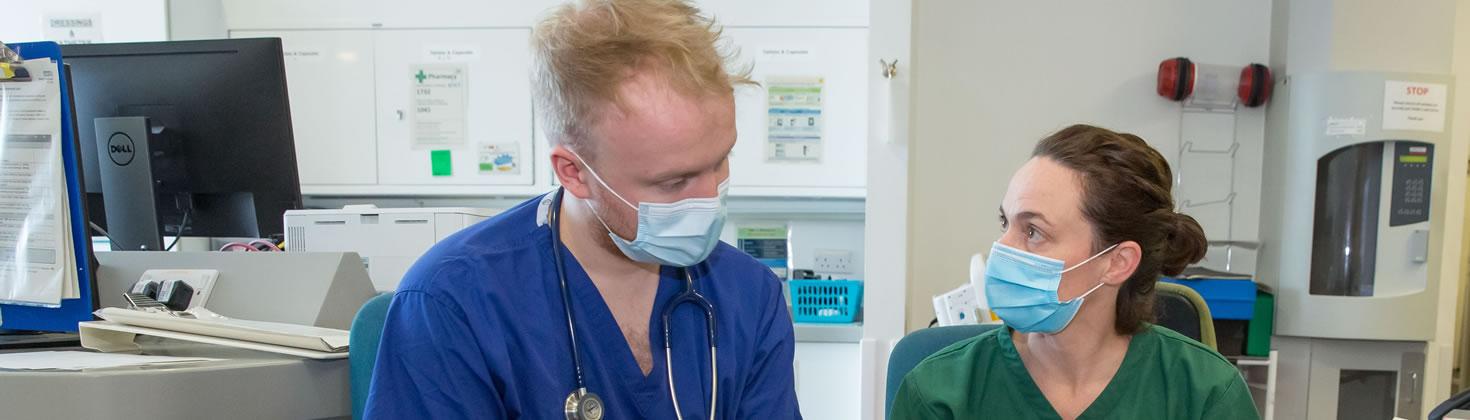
[{"left": 725, "top": 28, "right": 873, "bottom": 188}]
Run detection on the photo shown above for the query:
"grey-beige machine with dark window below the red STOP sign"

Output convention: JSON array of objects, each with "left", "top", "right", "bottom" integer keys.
[{"left": 1260, "top": 72, "right": 1452, "bottom": 419}]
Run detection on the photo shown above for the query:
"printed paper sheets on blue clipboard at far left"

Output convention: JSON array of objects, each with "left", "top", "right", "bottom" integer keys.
[{"left": 0, "top": 59, "right": 81, "bottom": 307}]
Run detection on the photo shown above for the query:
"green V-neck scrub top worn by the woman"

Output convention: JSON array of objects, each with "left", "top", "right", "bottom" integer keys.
[{"left": 889, "top": 325, "right": 1260, "bottom": 420}]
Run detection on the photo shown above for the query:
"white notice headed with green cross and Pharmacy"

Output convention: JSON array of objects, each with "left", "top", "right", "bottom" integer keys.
[{"left": 409, "top": 63, "right": 469, "bottom": 148}]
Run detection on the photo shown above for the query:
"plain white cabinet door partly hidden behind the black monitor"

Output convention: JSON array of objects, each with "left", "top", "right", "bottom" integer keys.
[{"left": 229, "top": 31, "right": 378, "bottom": 187}]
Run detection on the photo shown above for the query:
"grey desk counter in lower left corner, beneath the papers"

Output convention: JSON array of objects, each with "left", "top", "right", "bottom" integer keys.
[{"left": 0, "top": 336, "right": 351, "bottom": 419}]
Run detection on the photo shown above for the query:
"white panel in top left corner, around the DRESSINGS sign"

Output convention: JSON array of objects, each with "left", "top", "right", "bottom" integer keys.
[{"left": 0, "top": 0, "right": 168, "bottom": 43}]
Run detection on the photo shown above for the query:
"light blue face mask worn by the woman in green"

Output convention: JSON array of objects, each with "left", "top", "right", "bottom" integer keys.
[{"left": 985, "top": 242, "right": 1117, "bottom": 333}]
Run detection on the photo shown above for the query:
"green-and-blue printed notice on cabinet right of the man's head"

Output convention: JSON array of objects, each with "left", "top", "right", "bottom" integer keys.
[{"left": 766, "top": 78, "right": 822, "bottom": 163}]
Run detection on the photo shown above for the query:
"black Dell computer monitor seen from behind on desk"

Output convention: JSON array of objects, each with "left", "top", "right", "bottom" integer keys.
[{"left": 62, "top": 38, "right": 301, "bottom": 250}]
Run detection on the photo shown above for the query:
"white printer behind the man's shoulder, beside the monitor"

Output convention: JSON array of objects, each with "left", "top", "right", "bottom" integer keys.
[{"left": 285, "top": 206, "right": 498, "bottom": 292}]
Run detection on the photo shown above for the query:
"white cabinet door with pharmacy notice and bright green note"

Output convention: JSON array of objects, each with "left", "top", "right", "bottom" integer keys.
[{"left": 375, "top": 28, "right": 535, "bottom": 185}]
